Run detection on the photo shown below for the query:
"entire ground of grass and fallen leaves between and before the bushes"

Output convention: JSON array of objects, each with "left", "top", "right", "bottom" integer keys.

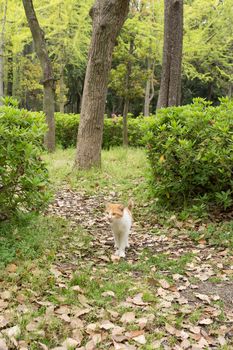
[{"left": 0, "top": 149, "right": 233, "bottom": 350}]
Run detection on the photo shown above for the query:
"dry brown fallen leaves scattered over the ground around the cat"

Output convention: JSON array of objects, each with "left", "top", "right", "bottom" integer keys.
[{"left": 0, "top": 188, "right": 233, "bottom": 350}]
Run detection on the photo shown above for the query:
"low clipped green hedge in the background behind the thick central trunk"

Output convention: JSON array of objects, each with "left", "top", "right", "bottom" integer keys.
[{"left": 55, "top": 113, "right": 154, "bottom": 149}]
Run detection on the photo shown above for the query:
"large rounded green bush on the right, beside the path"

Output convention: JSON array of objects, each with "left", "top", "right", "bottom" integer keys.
[{"left": 147, "top": 99, "right": 233, "bottom": 209}]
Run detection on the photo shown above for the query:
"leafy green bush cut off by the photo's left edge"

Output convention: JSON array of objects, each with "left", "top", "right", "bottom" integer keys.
[{"left": 0, "top": 105, "right": 48, "bottom": 218}]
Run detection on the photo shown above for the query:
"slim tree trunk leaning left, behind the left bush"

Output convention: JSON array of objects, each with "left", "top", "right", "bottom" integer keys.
[{"left": 23, "top": 0, "right": 55, "bottom": 152}]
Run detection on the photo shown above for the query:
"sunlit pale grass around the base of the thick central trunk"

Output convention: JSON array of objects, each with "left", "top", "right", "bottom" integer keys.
[{"left": 44, "top": 147, "right": 148, "bottom": 200}]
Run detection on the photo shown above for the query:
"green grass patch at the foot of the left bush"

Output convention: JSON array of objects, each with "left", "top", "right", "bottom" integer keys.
[{"left": 0, "top": 214, "right": 68, "bottom": 268}]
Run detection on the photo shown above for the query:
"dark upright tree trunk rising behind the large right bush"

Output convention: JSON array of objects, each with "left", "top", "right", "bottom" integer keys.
[{"left": 157, "top": 0, "right": 183, "bottom": 109}]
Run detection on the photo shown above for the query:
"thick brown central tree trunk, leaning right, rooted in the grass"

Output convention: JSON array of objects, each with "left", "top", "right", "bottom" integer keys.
[{"left": 75, "top": 0, "right": 129, "bottom": 169}]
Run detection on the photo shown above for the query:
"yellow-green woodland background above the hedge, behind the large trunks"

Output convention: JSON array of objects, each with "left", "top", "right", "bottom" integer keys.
[{"left": 0, "top": 0, "right": 233, "bottom": 116}]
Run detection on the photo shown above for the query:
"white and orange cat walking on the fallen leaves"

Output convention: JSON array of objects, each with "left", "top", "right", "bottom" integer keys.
[{"left": 106, "top": 200, "right": 133, "bottom": 258}]
